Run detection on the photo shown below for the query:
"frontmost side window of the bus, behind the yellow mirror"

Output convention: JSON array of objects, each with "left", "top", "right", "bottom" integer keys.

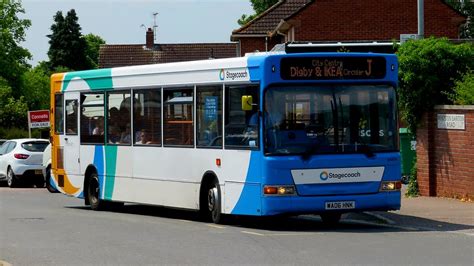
[{"left": 225, "top": 85, "right": 259, "bottom": 149}]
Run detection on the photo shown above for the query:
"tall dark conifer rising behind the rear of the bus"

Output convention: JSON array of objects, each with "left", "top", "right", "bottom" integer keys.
[{"left": 48, "top": 9, "right": 91, "bottom": 70}]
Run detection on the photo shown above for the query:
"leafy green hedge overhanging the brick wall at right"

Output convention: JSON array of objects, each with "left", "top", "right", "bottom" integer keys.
[{"left": 398, "top": 38, "right": 474, "bottom": 134}]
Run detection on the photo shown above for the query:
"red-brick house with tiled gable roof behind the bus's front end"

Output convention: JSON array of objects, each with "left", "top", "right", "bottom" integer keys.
[{"left": 231, "top": 0, "right": 466, "bottom": 55}]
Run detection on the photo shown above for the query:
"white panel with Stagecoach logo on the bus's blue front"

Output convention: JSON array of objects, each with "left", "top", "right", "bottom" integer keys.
[{"left": 291, "top": 166, "right": 385, "bottom": 185}]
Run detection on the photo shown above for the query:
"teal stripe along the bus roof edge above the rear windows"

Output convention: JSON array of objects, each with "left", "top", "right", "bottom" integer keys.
[{"left": 62, "top": 68, "right": 113, "bottom": 92}]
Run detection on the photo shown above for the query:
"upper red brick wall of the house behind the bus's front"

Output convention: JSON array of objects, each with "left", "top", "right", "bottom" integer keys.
[{"left": 294, "top": 0, "right": 462, "bottom": 41}]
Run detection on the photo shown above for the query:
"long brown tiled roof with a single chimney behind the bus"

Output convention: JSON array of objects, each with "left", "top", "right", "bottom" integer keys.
[{"left": 99, "top": 28, "right": 238, "bottom": 68}]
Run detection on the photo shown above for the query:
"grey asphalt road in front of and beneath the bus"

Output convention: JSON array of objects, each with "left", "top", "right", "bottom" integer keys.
[{"left": 0, "top": 187, "right": 474, "bottom": 266}]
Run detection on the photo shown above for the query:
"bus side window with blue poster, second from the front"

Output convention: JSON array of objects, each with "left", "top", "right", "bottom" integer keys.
[{"left": 196, "top": 86, "right": 222, "bottom": 148}]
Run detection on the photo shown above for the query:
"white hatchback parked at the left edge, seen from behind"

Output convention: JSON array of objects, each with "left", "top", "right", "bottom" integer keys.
[{"left": 0, "top": 139, "right": 49, "bottom": 187}]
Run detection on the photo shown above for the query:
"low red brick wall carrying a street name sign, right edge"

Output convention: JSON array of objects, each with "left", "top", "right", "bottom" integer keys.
[{"left": 416, "top": 106, "right": 474, "bottom": 199}]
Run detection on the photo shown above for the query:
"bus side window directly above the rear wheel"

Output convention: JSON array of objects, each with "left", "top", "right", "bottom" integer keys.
[{"left": 80, "top": 93, "right": 104, "bottom": 144}]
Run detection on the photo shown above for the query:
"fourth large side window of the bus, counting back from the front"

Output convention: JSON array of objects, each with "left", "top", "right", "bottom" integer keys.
[{"left": 133, "top": 89, "right": 161, "bottom": 145}]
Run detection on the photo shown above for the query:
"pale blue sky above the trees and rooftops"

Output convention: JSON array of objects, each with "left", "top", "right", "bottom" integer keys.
[{"left": 19, "top": 0, "right": 254, "bottom": 66}]
